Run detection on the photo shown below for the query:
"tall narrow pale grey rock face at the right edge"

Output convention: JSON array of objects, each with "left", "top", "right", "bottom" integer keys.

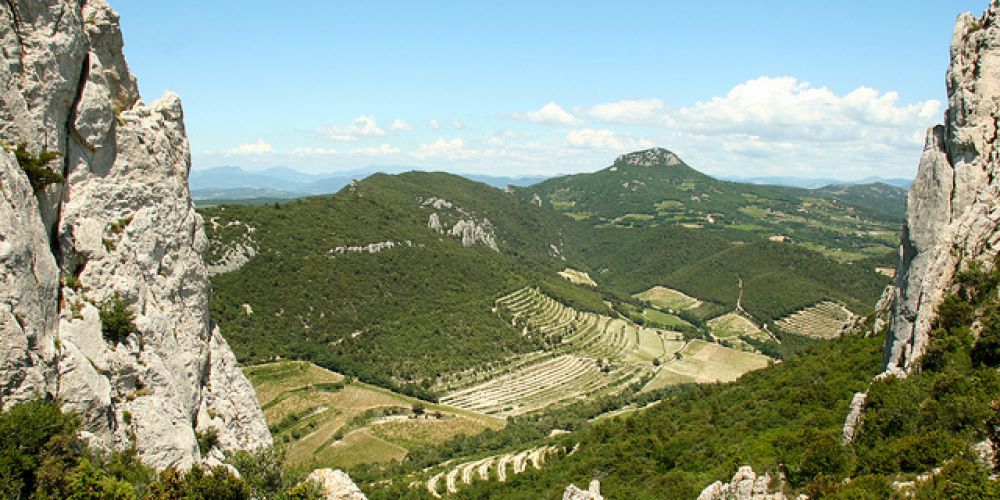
[{"left": 884, "top": 2, "right": 1000, "bottom": 376}]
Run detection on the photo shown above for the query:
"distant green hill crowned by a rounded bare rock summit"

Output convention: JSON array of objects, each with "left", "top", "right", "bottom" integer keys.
[{"left": 515, "top": 149, "right": 905, "bottom": 262}]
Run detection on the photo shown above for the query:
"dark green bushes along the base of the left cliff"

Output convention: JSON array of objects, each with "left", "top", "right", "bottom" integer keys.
[{"left": 0, "top": 400, "right": 321, "bottom": 500}]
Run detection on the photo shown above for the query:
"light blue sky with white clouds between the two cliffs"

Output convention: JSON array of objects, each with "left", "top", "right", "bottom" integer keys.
[{"left": 111, "top": 0, "right": 987, "bottom": 180}]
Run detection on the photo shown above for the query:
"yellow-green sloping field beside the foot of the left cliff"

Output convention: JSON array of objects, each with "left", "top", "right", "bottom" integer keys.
[{"left": 244, "top": 361, "right": 503, "bottom": 467}]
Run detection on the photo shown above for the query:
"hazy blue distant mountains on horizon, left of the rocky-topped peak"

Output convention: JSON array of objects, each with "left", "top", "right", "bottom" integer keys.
[{"left": 189, "top": 166, "right": 548, "bottom": 201}]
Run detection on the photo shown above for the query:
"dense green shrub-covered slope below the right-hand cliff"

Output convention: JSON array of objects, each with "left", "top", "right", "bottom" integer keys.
[{"left": 426, "top": 264, "right": 1000, "bottom": 498}]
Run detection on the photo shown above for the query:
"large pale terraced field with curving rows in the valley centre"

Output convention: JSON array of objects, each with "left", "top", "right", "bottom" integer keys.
[{"left": 439, "top": 288, "right": 684, "bottom": 417}]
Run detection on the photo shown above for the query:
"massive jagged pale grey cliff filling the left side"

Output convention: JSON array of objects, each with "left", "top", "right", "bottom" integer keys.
[{"left": 0, "top": 0, "right": 271, "bottom": 468}]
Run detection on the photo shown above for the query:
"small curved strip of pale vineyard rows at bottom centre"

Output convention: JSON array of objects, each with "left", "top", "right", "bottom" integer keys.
[{"left": 420, "top": 446, "right": 565, "bottom": 498}]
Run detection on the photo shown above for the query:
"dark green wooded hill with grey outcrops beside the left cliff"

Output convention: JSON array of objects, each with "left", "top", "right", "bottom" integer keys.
[{"left": 202, "top": 173, "right": 606, "bottom": 395}]
